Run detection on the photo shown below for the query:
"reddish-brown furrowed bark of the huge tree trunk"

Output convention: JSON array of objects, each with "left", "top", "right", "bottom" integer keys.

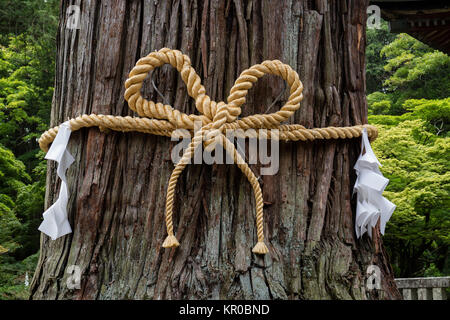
[{"left": 31, "top": 0, "right": 400, "bottom": 299}]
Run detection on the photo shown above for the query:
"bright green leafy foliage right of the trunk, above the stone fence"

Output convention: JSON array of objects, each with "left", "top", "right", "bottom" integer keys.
[{"left": 369, "top": 113, "right": 450, "bottom": 277}]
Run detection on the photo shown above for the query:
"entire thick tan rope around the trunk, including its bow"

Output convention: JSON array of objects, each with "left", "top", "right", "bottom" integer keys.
[{"left": 39, "top": 48, "right": 377, "bottom": 254}]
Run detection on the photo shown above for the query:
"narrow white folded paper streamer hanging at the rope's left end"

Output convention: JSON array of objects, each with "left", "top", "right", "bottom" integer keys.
[{"left": 38, "top": 121, "right": 74, "bottom": 240}]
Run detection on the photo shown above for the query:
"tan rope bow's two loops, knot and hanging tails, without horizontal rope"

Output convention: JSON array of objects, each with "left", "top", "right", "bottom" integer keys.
[{"left": 121, "top": 48, "right": 303, "bottom": 253}]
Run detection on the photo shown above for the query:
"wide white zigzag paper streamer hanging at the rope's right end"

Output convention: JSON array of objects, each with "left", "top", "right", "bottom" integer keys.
[{"left": 353, "top": 128, "right": 395, "bottom": 238}]
